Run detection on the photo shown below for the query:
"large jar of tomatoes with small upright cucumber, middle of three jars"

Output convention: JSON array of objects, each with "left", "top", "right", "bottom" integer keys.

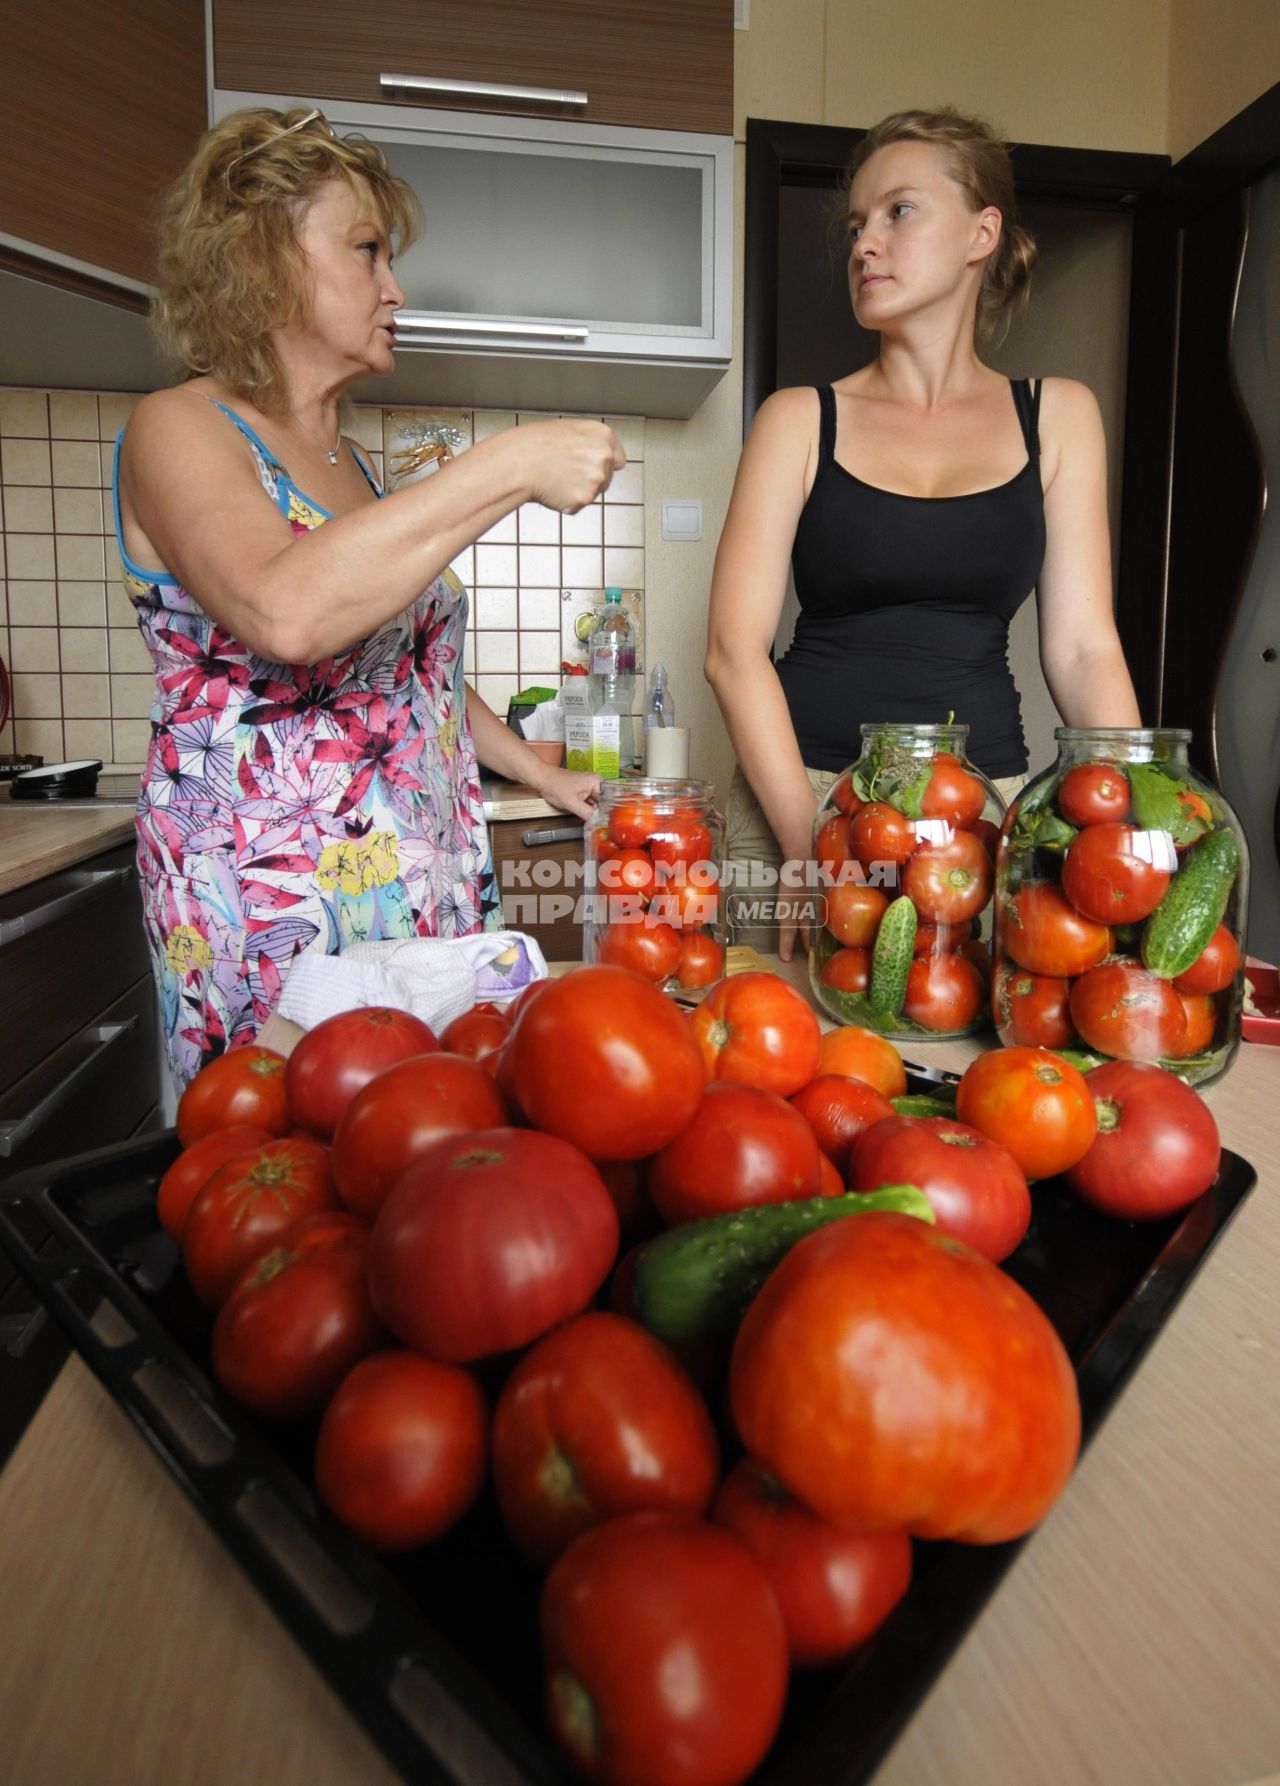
[{"left": 809, "top": 725, "right": 1003, "bottom": 1039}]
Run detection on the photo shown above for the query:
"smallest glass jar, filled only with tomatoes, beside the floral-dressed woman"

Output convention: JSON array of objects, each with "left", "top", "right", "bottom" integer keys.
[{"left": 582, "top": 777, "right": 725, "bottom": 986}]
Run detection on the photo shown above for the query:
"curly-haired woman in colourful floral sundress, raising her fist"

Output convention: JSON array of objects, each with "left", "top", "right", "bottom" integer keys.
[{"left": 114, "top": 111, "right": 623, "bottom": 1084}]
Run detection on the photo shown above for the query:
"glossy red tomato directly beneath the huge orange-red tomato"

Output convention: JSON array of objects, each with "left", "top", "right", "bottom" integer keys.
[{"left": 711, "top": 1457, "right": 910, "bottom": 1668}]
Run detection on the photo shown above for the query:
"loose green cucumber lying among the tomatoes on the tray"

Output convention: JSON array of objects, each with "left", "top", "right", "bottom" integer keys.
[{"left": 634, "top": 1184, "right": 934, "bottom": 1340}]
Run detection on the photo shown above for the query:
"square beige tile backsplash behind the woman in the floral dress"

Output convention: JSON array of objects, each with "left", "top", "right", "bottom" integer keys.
[{"left": 0, "top": 389, "right": 644, "bottom": 768}]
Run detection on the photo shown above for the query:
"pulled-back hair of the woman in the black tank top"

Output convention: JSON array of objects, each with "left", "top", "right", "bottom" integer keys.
[{"left": 841, "top": 105, "right": 1037, "bottom": 339}]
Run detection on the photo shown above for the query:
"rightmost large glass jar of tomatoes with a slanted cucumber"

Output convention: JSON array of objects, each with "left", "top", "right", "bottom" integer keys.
[{"left": 993, "top": 727, "right": 1248, "bottom": 1084}]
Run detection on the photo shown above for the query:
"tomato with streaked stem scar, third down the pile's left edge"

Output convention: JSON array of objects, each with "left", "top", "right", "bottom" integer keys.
[{"left": 182, "top": 1136, "right": 337, "bottom": 1309}]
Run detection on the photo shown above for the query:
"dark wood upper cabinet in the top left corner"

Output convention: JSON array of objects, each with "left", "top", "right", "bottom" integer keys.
[{"left": 0, "top": 0, "right": 207, "bottom": 284}]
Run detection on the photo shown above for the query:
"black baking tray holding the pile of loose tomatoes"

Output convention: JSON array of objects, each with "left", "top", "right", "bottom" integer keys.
[{"left": 0, "top": 1068, "right": 1255, "bottom": 1786}]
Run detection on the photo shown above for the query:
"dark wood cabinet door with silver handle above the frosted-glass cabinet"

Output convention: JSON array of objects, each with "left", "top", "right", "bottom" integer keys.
[{"left": 212, "top": 0, "right": 734, "bottom": 136}]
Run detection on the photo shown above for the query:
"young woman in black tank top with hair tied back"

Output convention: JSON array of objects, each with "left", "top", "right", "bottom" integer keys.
[{"left": 707, "top": 111, "right": 1139, "bottom": 957}]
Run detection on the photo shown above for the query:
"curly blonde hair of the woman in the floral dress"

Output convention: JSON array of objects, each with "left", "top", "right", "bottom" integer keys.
[{"left": 152, "top": 107, "right": 421, "bottom": 414}]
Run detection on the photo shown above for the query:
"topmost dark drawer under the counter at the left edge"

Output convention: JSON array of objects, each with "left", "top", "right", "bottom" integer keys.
[{"left": 0, "top": 845, "right": 150, "bottom": 1093}]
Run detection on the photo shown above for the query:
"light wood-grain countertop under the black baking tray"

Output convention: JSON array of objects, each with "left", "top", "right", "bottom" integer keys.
[{"left": 0, "top": 966, "right": 1280, "bottom": 1786}]
